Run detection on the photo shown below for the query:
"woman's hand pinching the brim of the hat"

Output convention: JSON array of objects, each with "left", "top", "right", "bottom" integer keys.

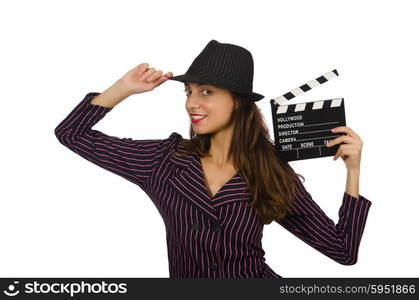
[{"left": 119, "top": 63, "right": 173, "bottom": 94}]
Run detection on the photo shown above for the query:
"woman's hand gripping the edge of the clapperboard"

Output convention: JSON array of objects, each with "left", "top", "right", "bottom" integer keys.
[{"left": 326, "top": 126, "right": 363, "bottom": 171}]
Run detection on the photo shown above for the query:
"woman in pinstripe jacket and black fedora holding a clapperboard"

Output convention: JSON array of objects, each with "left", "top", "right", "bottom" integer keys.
[{"left": 55, "top": 40, "right": 371, "bottom": 278}]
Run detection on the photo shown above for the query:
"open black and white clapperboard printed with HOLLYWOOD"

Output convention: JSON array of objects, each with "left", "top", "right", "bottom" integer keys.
[{"left": 270, "top": 69, "right": 346, "bottom": 161}]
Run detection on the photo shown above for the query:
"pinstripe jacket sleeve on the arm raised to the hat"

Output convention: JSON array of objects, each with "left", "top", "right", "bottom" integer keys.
[{"left": 55, "top": 92, "right": 181, "bottom": 191}]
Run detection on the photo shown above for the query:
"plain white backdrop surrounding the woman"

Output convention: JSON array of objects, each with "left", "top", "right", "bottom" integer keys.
[{"left": 0, "top": 0, "right": 419, "bottom": 277}]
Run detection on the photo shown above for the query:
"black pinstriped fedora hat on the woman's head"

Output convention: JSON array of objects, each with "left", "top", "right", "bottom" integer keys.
[{"left": 169, "top": 40, "right": 265, "bottom": 102}]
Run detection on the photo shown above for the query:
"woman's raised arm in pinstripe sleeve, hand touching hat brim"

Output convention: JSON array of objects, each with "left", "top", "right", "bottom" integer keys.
[{"left": 54, "top": 64, "right": 176, "bottom": 190}]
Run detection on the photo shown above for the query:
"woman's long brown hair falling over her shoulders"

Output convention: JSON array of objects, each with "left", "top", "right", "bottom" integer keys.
[{"left": 175, "top": 91, "right": 304, "bottom": 224}]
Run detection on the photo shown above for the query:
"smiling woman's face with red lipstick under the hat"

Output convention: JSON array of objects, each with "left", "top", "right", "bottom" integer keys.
[{"left": 185, "top": 82, "right": 235, "bottom": 134}]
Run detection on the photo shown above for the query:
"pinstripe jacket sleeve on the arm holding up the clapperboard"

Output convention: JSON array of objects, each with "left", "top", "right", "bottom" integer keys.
[{"left": 276, "top": 165, "right": 372, "bottom": 265}]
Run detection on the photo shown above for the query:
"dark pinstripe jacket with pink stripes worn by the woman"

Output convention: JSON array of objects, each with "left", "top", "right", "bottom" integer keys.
[{"left": 55, "top": 92, "right": 371, "bottom": 278}]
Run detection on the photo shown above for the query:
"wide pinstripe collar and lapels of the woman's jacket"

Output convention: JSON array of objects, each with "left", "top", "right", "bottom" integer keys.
[{"left": 168, "top": 146, "right": 250, "bottom": 221}]
